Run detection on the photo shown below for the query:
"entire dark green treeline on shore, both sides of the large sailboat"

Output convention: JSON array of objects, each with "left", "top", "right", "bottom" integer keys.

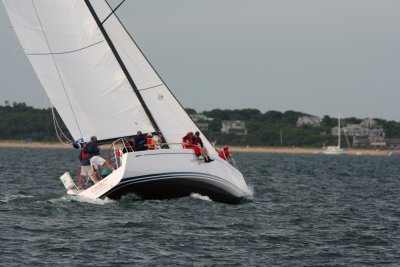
[{"left": 0, "top": 101, "right": 400, "bottom": 147}]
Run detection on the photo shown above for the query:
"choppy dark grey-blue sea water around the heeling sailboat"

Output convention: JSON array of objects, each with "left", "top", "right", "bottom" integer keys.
[{"left": 0, "top": 148, "right": 400, "bottom": 266}]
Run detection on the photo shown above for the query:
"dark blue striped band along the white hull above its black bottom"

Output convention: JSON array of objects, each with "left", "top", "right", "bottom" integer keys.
[{"left": 101, "top": 172, "right": 246, "bottom": 200}]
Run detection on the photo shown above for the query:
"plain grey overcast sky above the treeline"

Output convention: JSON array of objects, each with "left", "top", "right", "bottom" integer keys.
[{"left": 0, "top": 0, "right": 400, "bottom": 121}]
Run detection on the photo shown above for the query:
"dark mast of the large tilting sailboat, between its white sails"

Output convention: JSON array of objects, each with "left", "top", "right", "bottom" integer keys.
[{"left": 85, "top": 0, "right": 164, "bottom": 142}]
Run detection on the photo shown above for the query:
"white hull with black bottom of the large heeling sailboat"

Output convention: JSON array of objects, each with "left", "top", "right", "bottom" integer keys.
[{"left": 68, "top": 149, "right": 251, "bottom": 203}]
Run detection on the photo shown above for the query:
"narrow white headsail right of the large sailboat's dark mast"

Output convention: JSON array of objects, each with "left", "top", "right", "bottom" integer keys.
[{"left": 91, "top": 0, "right": 215, "bottom": 154}]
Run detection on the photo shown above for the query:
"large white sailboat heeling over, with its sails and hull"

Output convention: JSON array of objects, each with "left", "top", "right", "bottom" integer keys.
[{"left": 3, "top": 0, "right": 251, "bottom": 203}]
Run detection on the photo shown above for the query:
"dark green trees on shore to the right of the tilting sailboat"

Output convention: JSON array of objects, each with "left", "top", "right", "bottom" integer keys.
[{"left": 187, "top": 109, "right": 400, "bottom": 147}]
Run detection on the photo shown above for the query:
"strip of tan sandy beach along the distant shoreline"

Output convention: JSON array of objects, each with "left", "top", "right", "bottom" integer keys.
[{"left": 0, "top": 141, "right": 388, "bottom": 156}]
